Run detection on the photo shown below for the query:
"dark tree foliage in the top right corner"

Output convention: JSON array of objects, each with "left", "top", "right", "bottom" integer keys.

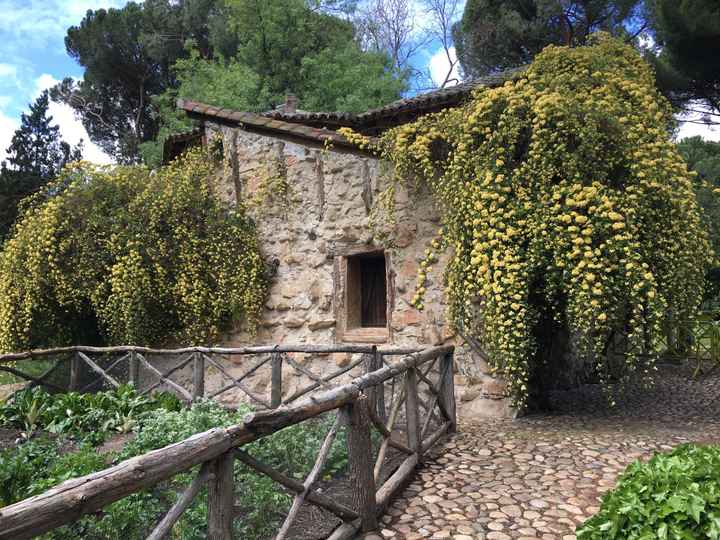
[{"left": 647, "top": 0, "right": 720, "bottom": 123}]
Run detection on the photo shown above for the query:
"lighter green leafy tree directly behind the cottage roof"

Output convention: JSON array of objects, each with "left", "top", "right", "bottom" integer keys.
[{"left": 141, "top": 0, "right": 407, "bottom": 166}]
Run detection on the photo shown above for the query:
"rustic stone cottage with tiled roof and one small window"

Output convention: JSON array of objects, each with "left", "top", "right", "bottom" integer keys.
[{"left": 164, "top": 73, "right": 513, "bottom": 416}]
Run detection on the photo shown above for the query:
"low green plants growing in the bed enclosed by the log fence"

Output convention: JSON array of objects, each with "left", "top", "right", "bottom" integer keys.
[{"left": 0, "top": 386, "right": 347, "bottom": 540}]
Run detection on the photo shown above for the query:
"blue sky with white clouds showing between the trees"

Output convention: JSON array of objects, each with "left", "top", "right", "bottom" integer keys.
[{"left": 0, "top": 0, "right": 720, "bottom": 162}]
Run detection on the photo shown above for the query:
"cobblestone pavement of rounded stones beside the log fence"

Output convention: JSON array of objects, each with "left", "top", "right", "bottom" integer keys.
[{"left": 381, "top": 366, "right": 720, "bottom": 540}]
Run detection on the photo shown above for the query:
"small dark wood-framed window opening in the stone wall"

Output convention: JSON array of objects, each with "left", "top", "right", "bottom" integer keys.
[{"left": 347, "top": 252, "right": 387, "bottom": 328}]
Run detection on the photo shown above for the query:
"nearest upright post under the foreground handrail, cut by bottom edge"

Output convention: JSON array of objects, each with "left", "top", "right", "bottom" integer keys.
[{"left": 207, "top": 450, "right": 235, "bottom": 540}]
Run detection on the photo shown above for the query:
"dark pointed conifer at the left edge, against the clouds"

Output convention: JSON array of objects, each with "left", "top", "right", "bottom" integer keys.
[{"left": 0, "top": 92, "right": 82, "bottom": 240}]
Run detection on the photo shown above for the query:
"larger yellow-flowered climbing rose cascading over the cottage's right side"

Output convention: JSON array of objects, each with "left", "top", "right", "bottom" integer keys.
[{"left": 346, "top": 34, "right": 710, "bottom": 406}]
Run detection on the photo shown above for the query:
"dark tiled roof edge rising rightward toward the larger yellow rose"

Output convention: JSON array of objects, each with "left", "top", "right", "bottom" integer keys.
[{"left": 263, "top": 67, "right": 526, "bottom": 132}]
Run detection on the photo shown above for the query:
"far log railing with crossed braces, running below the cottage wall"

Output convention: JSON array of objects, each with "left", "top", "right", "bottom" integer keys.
[{"left": 0, "top": 345, "right": 428, "bottom": 409}]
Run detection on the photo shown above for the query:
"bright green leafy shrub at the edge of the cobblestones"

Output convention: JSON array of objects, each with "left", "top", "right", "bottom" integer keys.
[{"left": 577, "top": 445, "right": 720, "bottom": 540}]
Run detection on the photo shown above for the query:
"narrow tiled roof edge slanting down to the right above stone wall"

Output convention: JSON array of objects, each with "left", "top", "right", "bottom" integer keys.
[{"left": 177, "top": 99, "right": 362, "bottom": 148}]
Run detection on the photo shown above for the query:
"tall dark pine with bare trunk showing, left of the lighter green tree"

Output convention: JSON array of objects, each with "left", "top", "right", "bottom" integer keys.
[{"left": 53, "top": 0, "right": 229, "bottom": 162}]
